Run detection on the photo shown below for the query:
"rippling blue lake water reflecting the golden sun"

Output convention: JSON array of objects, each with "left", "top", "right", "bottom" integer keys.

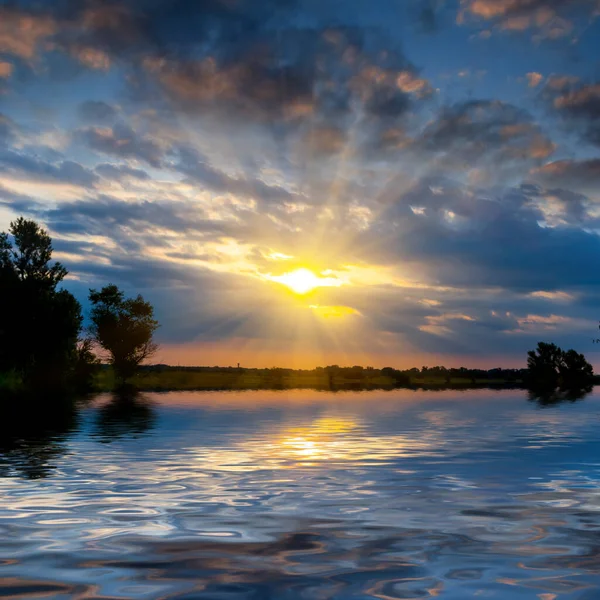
[{"left": 0, "top": 388, "right": 600, "bottom": 600}]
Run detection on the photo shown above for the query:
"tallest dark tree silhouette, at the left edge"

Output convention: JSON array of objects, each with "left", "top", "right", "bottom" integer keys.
[{"left": 0, "top": 217, "right": 82, "bottom": 386}]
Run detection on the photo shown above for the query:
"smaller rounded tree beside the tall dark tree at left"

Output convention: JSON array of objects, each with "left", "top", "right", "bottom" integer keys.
[{"left": 90, "top": 284, "right": 158, "bottom": 383}]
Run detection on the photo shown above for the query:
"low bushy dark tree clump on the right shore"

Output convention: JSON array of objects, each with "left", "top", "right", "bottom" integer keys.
[{"left": 527, "top": 342, "right": 594, "bottom": 389}]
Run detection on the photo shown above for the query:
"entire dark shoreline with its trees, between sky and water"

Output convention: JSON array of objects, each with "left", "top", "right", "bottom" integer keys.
[{"left": 0, "top": 217, "right": 594, "bottom": 397}]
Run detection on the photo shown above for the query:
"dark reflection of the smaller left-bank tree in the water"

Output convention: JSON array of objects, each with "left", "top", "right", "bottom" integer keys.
[{"left": 95, "top": 391, "right": 156, "bottom": 442}]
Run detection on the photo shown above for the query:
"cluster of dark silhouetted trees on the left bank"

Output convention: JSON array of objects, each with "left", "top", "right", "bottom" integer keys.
[{"left": 0, "top": 217, "right": 158, "bottom": 391}]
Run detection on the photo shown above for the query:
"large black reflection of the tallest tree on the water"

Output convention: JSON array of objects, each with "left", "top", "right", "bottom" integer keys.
[{"left": 0, "top": 395, "right": 79, "bottom": 479}]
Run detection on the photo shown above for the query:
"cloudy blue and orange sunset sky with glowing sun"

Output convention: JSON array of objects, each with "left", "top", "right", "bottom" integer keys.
[{"left": 0, "top": 0, "right": 600, "bottom": 368}]
